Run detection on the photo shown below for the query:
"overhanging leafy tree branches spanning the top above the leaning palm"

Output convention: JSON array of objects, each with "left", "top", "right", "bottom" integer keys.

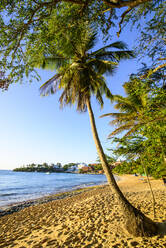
[{"left": 0, "top": 0, "right": 166, "bottom": 89}]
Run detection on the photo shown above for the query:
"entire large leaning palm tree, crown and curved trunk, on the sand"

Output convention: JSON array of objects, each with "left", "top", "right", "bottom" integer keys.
[{"left": 38, "top": 32, "right": 157, "bottom": 236}]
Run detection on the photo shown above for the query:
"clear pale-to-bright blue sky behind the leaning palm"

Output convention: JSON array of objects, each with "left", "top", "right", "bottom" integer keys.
[{"left": 0, "top": 27, "right": 138, "bottom": 169}]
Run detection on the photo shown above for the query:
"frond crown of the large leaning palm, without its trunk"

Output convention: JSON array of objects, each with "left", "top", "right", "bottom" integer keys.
[{"left": 41, "top": 32, "right": 133, "bottom": 111}]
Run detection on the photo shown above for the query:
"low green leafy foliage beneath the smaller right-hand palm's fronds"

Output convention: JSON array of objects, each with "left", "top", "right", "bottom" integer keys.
[{"left": 113, "top": 136, "right": 166, "bottom": 178}]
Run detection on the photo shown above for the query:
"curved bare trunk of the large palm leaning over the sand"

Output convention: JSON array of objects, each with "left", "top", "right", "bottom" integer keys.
[{"left": 86, "top": 99, "right": 157, "bottom": 236}]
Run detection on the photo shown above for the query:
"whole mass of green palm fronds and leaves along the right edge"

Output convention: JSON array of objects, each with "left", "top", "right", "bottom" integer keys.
[{"left": 107, "top": 77, "right": 166, "bottom": 178}]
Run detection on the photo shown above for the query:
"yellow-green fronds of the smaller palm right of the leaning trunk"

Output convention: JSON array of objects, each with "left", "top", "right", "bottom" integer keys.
[{"left": 102, "top": 79, "right": 166, "bottom": 137}]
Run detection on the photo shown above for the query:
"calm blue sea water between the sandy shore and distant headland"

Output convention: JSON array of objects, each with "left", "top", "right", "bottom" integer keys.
[{"left": 0, "top": 170, "right": 107, "bottom": 209}]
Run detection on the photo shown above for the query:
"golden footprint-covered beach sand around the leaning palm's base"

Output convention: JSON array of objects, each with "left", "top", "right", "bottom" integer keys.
[{"left": 0, "top": 175, "right": 166, "bottom": 248}]
